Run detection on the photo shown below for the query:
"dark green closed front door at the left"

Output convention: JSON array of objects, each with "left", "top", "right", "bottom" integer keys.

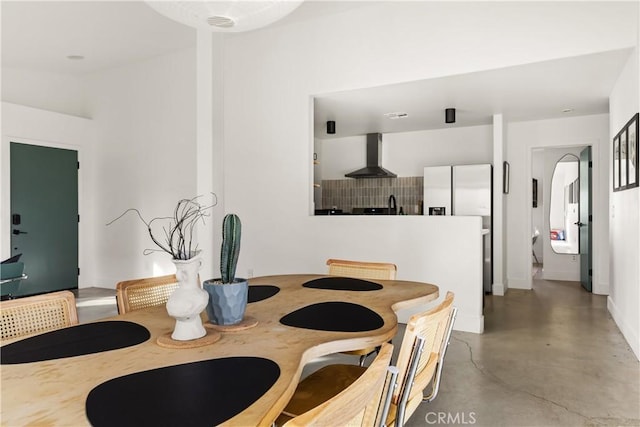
[{"left": 9, "top": 142, "right": 78, "bottom": 296}]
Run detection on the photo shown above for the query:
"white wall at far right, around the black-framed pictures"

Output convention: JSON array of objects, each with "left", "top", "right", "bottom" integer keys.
[{"left": 607, "top": 46, "right": 640, "bottom": 358}]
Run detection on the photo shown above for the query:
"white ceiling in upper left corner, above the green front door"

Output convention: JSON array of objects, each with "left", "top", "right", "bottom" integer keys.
[{"left": 0, "top": 0, "right": 196, "bottom": 75}]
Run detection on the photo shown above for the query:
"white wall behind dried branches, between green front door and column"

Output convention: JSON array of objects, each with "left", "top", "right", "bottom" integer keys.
[{"left": 87, "top": 49, "right": 198, "bottom": 287}]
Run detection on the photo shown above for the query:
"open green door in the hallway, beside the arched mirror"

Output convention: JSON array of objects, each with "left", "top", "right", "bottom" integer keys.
[{"left": 578, "top": 147, "right": 592, "bottom": 292}]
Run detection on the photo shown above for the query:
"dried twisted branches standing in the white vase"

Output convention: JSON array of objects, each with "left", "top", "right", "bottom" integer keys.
[{"left": 107, "top": 194, "right": 217, "bottom": 260}]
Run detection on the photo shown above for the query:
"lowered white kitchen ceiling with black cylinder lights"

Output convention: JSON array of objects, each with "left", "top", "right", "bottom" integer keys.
[{"left": 314, "top": 49, "right": 632, "bottom": 139}]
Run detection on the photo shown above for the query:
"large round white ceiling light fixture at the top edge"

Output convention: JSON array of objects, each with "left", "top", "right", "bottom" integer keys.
[{"left": 146, "top": 0, "right": 303, "bottom": 32}]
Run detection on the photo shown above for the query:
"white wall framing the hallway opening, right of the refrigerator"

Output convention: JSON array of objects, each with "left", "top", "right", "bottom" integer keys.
[{"left": 507, "top": 114, "right": 610, "bottom": 295}]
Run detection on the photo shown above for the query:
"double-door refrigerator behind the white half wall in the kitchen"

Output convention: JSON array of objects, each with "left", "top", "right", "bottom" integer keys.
[{"left": 423, "top": 164, "right": 493, "bottom": 293}]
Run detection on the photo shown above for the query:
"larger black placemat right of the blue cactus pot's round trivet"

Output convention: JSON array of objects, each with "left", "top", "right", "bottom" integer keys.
[{"left": 280, "top": 301, "right": 384, "bottom": 332}]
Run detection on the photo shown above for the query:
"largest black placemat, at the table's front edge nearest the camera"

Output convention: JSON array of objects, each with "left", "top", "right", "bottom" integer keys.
[{"left": 86, "top": 357, "right": 280, "bottom": 427}]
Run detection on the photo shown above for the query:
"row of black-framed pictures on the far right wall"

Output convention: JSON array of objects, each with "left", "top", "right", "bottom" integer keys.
[{"left": 613, "top": 113, "right": 640, "bottom": 191}]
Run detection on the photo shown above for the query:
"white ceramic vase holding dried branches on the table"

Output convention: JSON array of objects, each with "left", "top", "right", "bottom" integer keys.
[{"left": 167, "top": 255, "right": 209, "bottom": 341}]
